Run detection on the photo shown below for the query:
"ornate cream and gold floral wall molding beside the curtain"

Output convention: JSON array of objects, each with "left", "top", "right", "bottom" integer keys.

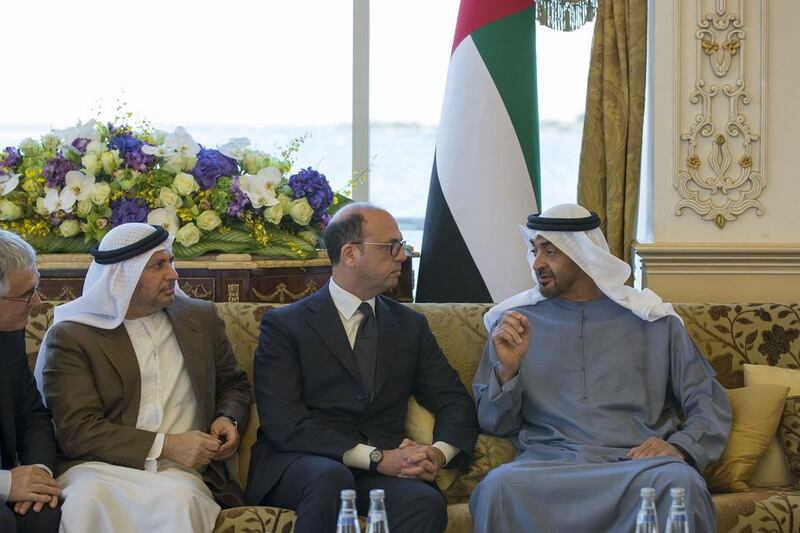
[{"left": 674, "top": 0, "right": 766, "bottom": 229}]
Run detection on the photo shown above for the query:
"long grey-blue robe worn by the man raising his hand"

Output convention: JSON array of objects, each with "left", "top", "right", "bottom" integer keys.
[{"left": 470, "top": 297, "right": 731, "bottom": 533}]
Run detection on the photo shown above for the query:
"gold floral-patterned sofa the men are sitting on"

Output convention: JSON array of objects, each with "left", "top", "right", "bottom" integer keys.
[{"left": 26, "top": 302, "right": 800, "bottom": 533}]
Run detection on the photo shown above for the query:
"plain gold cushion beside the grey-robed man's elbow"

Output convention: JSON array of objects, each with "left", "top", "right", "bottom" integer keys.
[{"left": 705, "top": 385, "right": 788, "bottom": 492}]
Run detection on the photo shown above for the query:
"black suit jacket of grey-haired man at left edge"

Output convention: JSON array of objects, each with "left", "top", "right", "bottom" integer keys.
[{"left": 0, "top": 330, "right": 56, "bottom": 471}]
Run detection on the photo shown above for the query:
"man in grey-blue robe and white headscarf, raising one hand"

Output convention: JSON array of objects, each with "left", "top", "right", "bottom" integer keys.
[{"left": 470, "top": 204, "right": 731, "bottom": 533}]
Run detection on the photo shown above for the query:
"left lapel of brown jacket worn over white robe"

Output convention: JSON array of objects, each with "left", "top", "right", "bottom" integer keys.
[{"left": 100, "top": 324, "right": 142, "bottom": 426}]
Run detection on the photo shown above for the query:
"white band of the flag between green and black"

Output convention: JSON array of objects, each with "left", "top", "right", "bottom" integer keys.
[{"left": 436, "top": 36, "right": 536, "bottom": 302}]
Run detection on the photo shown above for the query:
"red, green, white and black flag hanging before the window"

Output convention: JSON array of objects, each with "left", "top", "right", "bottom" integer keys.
[{"left": 416, "top": 0, "right": 540, "bottom": 302}]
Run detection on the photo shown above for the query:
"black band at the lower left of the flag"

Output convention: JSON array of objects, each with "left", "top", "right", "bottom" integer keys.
[{"left": 415, "top": 156, "right": 492, "bottom": 303}]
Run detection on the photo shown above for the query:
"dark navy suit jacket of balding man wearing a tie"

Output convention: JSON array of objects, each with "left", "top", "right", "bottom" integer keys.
[{"left": 246, "top": 285, "right": 478, "bottom": 504}]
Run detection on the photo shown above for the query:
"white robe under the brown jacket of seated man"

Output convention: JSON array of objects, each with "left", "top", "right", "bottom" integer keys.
[{"left": 58, "top": 312, "right": 220, "bottom": 533}]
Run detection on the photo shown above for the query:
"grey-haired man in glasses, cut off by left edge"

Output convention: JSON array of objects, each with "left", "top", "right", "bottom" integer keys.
[{"left": 0, "top": 230, "right": 61, "bottom": 532}]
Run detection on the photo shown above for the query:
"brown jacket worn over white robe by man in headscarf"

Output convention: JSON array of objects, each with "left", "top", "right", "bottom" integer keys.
[{"left": 42, "top": 297, "right": 251, "bottom": 506}]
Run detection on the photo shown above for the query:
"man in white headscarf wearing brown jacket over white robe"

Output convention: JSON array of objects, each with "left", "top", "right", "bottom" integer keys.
[{"left": 36, "top": 223, "right": 251, "bottom": 533}]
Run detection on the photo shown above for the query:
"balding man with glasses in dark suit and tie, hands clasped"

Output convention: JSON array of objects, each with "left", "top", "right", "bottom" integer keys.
[{"left": 246, "top": 204, "right": 478, "bottom": 533}]
